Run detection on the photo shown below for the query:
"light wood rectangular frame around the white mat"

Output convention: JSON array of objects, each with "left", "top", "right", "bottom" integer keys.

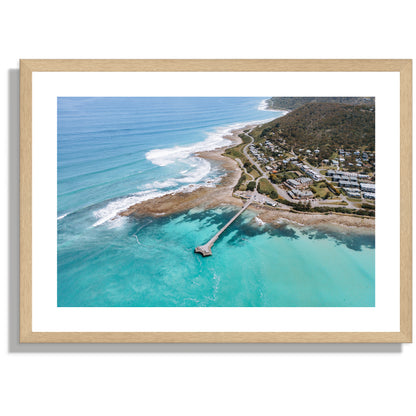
[{"left": 20, "top": 59, "right": 412, "bottom": 343}]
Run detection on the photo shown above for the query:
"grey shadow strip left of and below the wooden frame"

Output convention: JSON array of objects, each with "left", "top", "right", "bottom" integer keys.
[{"left": 8, "top": 69, "right": 402, "bottom": 354}]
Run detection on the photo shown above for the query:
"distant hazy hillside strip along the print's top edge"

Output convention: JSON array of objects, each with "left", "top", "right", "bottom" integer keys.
[{"left": 266, "top": 97, "right": 375, "bottom": 111}]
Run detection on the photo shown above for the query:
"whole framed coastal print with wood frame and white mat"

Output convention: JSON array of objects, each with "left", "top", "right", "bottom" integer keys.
[{"left": 20, "top": 60, "right": 412, "bottom": 343}]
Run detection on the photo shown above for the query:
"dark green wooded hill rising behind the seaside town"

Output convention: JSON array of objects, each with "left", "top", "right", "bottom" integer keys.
[{"left": 253, "top": 103, "right": 375, "bottom": 161}]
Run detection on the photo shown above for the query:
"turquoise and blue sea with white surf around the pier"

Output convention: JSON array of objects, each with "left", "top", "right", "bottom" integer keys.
[{"left": 57, "top": 97, "right": 375, "bottom": 307}]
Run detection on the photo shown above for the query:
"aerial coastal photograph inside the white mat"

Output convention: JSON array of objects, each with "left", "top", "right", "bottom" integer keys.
[{"left": 57, "top": 96, "right": 376, "bottom": 308}]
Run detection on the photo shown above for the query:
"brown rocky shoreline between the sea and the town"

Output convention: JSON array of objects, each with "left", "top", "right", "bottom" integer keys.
[{"left": 119, "top": 122, "right": 375, "bottom": 232}]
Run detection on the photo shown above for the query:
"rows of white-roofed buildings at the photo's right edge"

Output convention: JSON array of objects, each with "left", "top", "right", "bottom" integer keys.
[{"left": 326, "top": 170, "right": 376, "bottom": 199}]
